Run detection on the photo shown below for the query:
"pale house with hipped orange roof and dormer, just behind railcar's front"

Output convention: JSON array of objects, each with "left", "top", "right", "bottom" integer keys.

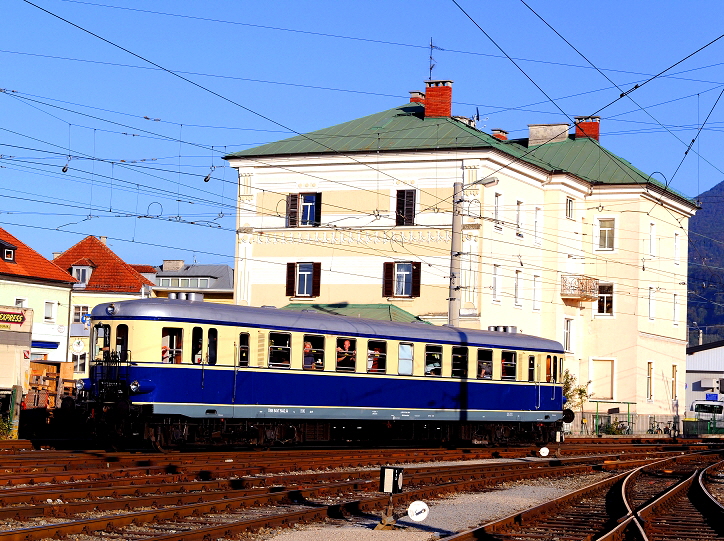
[{"left": 53, "top": 235, "right": 153, "bottom": 378}]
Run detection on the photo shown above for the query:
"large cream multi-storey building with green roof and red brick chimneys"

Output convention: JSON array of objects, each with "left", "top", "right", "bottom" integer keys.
[{"left": 227, "top": 81, "right": 696, "bottom": 431}]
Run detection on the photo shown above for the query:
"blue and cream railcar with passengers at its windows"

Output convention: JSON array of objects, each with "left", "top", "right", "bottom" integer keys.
[{"left": 84, "top": 299, "right": 564, "bottom": 442}]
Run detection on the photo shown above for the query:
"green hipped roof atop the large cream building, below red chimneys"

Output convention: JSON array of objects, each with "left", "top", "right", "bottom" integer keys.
[{"left": 225, "top": 103, "right": 691, "bottom": 203}]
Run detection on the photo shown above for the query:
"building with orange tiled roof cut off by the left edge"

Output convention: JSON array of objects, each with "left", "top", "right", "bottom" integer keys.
[{"left": 0, "top": 228, "right": 76, "bottom": 407}]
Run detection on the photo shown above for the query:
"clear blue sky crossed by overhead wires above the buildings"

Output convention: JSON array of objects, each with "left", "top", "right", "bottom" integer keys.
[{"left": 0, "top": 0, "right": 724, "bottom": 265}]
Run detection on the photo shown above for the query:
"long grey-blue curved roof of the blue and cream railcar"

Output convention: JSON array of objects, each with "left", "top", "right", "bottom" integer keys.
[{"left": 91, "top": 298, "right": 563, "bottom": 353}]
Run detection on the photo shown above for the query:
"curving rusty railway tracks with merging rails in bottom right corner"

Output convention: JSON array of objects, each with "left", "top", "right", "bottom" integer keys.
[{"left": 447, "top": 453, "right": 724, "bottom": 541}]
